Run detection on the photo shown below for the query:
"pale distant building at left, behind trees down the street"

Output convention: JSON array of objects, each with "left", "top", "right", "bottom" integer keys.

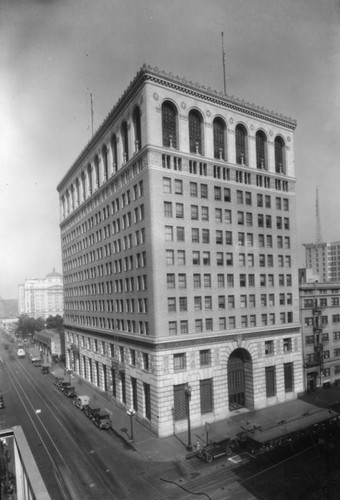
[{"left": 19, "top": 269, "right": 64, "bottom": 319}]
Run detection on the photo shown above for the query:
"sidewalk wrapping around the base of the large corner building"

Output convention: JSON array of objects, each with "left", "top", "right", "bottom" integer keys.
[{"left": 51, "top": 365, "right": 340, "bottom": 462}]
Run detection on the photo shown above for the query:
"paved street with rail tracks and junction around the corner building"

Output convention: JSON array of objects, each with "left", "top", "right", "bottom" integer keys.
[{"left": 0, "top": 343, "right": 340, "bottom": 500}]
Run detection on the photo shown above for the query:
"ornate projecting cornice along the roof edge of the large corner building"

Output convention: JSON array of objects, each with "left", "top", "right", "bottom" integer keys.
[{"left": 57, "top": 64, "right": 297, "bottom": 191}]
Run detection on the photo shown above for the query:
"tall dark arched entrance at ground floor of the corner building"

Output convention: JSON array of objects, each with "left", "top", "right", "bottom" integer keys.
[{"left": 228, "top": 348, "right": 253, "bottom": 411}]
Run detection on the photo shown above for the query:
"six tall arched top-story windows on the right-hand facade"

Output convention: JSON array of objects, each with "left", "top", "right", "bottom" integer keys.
[{"left": 162, "top": 100, "right": 286, "bottom": 173}]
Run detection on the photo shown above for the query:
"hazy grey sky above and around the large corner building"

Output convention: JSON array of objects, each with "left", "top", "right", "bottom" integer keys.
[{"left": 0, "top": 0, "right": 340, "bottom": 299}]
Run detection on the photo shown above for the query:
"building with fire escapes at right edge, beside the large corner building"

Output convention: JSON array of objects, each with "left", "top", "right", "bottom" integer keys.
[{"left": 300, "top": 281, "right": 340, "bottom": 392}]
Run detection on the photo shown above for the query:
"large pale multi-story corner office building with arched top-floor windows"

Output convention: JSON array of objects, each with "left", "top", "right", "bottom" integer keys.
[{"left": 58, "top": 66, "right": 303, "bottom": 436}]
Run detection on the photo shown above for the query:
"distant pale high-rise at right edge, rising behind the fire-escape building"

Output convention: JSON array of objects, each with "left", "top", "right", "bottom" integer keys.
[{"left": 304, "top": 241, "right": 340, "bottom": 281}]
